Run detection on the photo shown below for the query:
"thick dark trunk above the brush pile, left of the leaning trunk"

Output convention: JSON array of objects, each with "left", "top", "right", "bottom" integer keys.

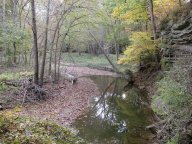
[{"left": 31, "top": 0, "right": 39, "bottom": 85}]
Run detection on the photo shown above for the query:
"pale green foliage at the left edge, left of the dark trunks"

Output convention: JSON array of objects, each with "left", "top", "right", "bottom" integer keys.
[{"left": 0, "top": 23, "right": 31, "bottom": 66}]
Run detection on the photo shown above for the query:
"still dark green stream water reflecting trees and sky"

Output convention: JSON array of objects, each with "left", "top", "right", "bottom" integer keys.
[{"left": 73, "top": 76, "right": 153, "bottom": 144}]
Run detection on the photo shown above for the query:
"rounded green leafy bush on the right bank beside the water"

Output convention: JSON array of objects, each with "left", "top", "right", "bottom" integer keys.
[{"left": 153, "top": 77, "right": 188, "bottom": 114}]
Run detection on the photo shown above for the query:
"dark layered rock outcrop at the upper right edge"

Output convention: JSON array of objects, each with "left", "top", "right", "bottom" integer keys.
[{"left": 161, "top": 3, "right": 192, "bottom": 46}]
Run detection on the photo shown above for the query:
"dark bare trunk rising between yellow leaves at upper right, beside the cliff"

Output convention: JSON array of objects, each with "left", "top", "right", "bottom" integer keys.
[{"left": 149, "top": 0, "right": 157, "bottom": 39}]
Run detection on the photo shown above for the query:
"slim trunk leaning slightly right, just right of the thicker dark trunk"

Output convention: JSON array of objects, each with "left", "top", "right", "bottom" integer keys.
[{"left": 40, "top": 0, "right": 51, "bottom": 86}]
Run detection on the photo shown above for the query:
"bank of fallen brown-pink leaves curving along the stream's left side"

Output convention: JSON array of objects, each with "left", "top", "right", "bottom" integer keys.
[{"left": 21, "top": 67, "right": 114, "bottom": 126}]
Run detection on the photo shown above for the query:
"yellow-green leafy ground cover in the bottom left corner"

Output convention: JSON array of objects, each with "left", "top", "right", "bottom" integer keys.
[{"left": 0, "top": 111, "right": 85, "bottom": 144}]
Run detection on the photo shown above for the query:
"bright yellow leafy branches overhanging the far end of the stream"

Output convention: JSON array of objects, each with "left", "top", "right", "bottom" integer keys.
[{"left": 118, "top": 32, "right": 158, "bottom": 64}]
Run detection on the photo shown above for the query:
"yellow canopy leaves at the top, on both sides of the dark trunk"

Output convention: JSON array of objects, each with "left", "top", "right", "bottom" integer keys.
[{"left": 112, "top": 0, "right": 179, "bottom": 23}]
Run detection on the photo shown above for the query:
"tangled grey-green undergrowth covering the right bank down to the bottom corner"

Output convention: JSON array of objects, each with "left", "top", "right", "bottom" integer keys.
[{"left": 152, "top": 60, "right": 192, "bottom": 144}]
